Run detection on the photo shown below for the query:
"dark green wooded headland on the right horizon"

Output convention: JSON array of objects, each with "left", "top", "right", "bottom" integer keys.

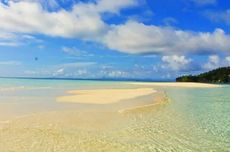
[{"left": 176, "top": 67, "right": 230, "bottom": 83}]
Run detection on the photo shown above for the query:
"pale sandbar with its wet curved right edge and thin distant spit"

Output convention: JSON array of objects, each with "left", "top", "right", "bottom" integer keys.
[{"left": 56, "top": 82, "right": 218, "bottom": 113}]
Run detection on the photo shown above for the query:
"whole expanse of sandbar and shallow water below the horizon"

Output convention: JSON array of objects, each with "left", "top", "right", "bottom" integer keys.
[{"left": 0, "top": 80, "right": 230, "bottom": 152}]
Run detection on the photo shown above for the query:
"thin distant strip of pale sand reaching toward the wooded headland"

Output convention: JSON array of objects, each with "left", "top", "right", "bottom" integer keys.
[{"left": 129, "top": 82, "right": 220, "bottom": 88}]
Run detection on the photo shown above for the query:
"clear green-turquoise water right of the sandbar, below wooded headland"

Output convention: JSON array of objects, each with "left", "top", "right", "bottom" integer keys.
[{"left": 164, "top": 85, "right": 230, "bottom": 151}]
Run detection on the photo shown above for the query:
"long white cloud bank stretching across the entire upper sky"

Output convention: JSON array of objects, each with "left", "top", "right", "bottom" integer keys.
[{"left": 0, "top": 0, "right": 230, "bottom": 55}]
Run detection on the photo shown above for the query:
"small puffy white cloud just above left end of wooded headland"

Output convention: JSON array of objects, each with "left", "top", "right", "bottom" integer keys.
[{"left": 161, "top": 55, "right": 192, "bottom": 71}]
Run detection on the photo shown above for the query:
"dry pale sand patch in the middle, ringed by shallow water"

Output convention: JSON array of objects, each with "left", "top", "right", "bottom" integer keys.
[{"left": 57, "top": 88, "right": 156, "bottom": 104}]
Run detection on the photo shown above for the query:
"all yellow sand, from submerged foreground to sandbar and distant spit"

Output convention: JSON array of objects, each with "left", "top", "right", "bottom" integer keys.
[{"left": 0, "top": 83, "right": 223, "bottom": 152}]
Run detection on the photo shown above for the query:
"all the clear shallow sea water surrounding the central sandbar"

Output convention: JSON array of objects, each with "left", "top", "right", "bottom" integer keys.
[{"left": 0, "top": 79, "right": 230, "bottom": 152}]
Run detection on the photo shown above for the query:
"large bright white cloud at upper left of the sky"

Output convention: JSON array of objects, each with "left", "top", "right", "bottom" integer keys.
[{"left": 0, "top": 2, "right": 105, "bottom": 38}]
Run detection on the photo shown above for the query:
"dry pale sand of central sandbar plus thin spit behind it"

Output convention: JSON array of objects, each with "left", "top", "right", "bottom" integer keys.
[{"left": 57, "top": 82, "right": 220, "bottom": 104}]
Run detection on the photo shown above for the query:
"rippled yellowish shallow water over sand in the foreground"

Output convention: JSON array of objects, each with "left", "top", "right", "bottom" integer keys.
[{"left": 0, "top": 102, "right": 227, "bottom": 152}]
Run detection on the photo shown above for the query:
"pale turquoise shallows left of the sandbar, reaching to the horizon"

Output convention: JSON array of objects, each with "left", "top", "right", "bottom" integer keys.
[{"left": 0, "top": 78, "right": 126, "bottom": 117}]
